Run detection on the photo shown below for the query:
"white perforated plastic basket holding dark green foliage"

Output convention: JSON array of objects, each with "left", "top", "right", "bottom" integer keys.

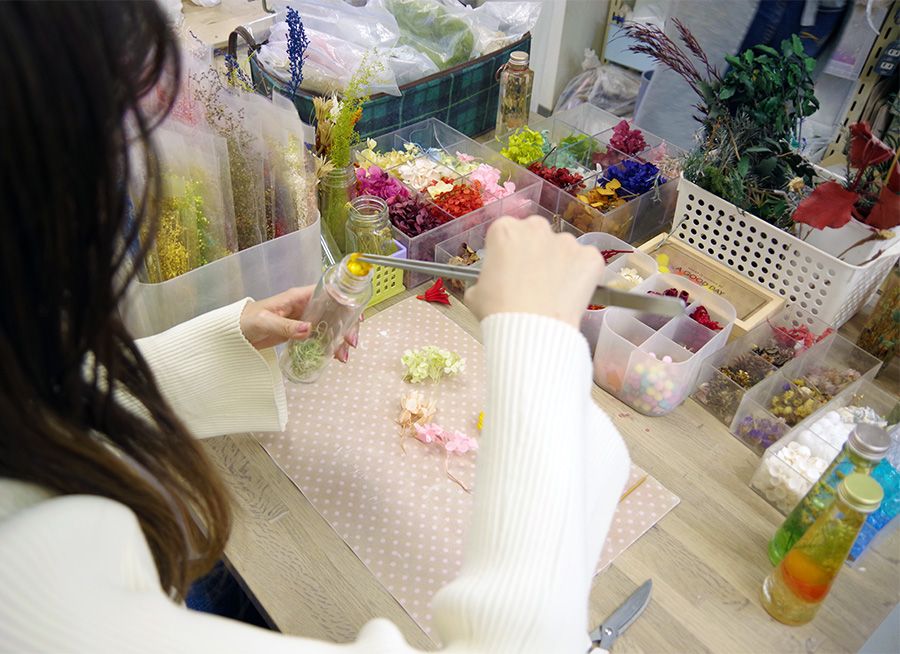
[{"left": 672, "top": 178, "right": 900, "bottom": 328}]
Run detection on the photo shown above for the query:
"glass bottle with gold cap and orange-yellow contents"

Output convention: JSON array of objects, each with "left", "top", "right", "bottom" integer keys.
[{"left": 762, "top": 473, "right": 884, "bottom": 625}]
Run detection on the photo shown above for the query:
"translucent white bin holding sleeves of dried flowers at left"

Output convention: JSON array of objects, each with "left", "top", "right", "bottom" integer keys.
[{"left": 121, "top": 219, "right": 322, "bottom": 338}]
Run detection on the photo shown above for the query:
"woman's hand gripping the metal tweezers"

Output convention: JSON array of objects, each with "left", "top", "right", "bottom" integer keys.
[{"left": 465, "top": 216, "right": 606, "bottom": 329}]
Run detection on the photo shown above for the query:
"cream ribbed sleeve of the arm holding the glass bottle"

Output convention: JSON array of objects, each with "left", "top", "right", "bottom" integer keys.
[{"left": 137, "top": 298, "right": 287, "bottom": 438}]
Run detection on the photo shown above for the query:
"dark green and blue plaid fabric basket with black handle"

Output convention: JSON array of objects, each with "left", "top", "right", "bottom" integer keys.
[{"left": 228, "top": 27, "right": 531, "bottom": 138}]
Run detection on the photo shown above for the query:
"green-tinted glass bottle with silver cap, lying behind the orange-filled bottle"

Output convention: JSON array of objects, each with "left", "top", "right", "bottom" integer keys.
[{"left": 769, "top": 423, "right": 891, "bottom": 565}]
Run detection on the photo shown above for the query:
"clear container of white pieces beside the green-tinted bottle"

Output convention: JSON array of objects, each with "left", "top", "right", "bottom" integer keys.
[{"left": 750, "top": 380, "right": 898, "bottom": 515}]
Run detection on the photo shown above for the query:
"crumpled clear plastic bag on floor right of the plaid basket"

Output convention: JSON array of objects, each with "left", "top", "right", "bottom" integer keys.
[{"left": 554, "top": 49, "right": 641, "bottom": 115}]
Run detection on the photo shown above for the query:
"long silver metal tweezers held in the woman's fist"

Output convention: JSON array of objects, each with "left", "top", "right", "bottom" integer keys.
[{"left": 357, "top": 254, "right": 685, "bottom": 316}]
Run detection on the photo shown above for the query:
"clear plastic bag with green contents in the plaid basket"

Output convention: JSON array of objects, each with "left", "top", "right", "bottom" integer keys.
[{"left": 378, "top": 0, "right": 476, "bottom": 70}]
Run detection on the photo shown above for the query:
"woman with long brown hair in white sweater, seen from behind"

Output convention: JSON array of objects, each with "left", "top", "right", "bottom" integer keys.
[{"left": 0, "top": 2, "right": 628, "bottom": 654}]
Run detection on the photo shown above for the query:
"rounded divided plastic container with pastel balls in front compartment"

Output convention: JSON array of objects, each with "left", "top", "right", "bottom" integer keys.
[{"left": 594, "top": 260, "right": 735, "bottom": 416}]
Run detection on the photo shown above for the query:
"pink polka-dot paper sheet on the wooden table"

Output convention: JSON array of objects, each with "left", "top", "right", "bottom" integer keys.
[{"left": 257, "top": 298, "right": 678, "bottom": 637}]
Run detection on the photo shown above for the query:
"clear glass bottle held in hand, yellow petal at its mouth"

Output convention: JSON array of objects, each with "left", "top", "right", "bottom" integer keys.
[{"left": 279, "top": 255, "right": 372, "bottom": 384}]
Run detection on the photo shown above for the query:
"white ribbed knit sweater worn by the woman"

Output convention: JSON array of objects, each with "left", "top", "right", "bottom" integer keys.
[{"left": 0, "top": 300, "right": 628, "bottom": 654}]
